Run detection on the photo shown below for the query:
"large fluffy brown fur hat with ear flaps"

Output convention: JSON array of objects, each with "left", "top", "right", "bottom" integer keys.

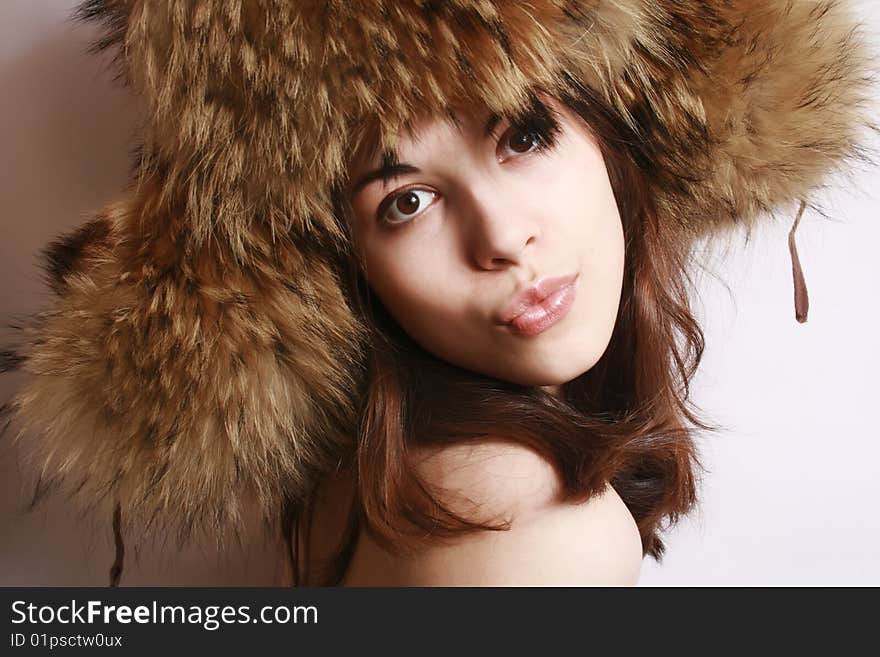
[{"left": 3, "top": 0, "right": 870, "bottom": 576}]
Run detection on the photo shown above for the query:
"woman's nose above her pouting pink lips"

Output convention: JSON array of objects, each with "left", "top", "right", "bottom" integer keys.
[{"left": 462, "top": 178, "right": 541, "bottom": 269}]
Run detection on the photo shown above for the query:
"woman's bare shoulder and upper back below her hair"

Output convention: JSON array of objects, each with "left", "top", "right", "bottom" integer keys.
[{"left": 340, "top": 441, "right": 642, "bottom": 586}]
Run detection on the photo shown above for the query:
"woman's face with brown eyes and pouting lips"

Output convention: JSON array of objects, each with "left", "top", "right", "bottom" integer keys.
[{"left": 349, "top": 96, "right": 624, "bottom": 392}]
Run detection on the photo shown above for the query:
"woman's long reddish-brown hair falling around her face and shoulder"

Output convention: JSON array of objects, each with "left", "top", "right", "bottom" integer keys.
[{"left": 282, "top": 83, "right": 717, "bottom": 585}]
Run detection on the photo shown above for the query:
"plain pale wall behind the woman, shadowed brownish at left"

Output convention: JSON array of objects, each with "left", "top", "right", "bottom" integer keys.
[{"left": 0, "top": 0, "right": 880, "bottom": 586}]
